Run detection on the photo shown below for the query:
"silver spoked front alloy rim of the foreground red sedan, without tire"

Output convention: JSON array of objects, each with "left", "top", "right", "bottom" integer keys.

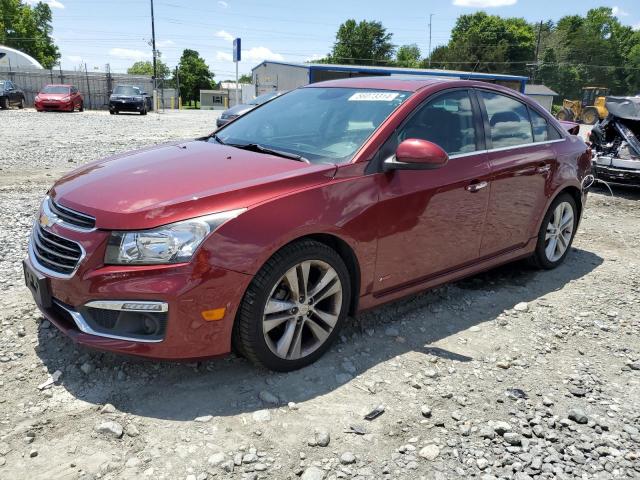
[{"left": 262, "top": 260, "right": 343, "bottom": 360}]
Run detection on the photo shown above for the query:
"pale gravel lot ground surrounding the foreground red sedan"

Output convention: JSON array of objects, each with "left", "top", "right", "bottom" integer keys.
[{"left": 0, "top": 110, "right": 640, "bottom": 480}]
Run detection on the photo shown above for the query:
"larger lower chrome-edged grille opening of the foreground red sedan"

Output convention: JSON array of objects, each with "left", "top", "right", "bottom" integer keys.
[{"left": 31, "top": 225, "right": 82, "bottom": 275}]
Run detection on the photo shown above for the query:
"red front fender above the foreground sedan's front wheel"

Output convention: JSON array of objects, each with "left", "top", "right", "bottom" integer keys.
[{"left": 204, "top": 164, "right": 378, "bottom": 291}]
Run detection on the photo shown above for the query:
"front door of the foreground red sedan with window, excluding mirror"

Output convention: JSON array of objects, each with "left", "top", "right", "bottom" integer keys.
[{"left": 374, "top": 89, "right": 490, "bottom": 293}]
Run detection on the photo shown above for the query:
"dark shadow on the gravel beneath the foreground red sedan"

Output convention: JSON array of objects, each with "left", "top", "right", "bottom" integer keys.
[{"left": 36, "top": 248, "right": 603, "bottom": 420}]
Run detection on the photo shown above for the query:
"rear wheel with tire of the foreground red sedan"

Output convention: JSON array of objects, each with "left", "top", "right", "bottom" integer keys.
[{"left": 529, "top": 193, "right": 578, "bottom": 270}]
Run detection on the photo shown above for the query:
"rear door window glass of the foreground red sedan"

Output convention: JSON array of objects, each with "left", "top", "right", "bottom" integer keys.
[{"left": 480, "top": 90, "right": 533, "bottom": 148}]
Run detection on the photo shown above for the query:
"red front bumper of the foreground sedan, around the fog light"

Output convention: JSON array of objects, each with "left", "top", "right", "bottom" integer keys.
[{"left": 26, "top": 225, "right": 252, "bottom": 360}]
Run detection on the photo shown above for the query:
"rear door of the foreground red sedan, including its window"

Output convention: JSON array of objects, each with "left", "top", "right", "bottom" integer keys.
[{"left": 478, "top": 90, "right": 562, "bottom": 257}]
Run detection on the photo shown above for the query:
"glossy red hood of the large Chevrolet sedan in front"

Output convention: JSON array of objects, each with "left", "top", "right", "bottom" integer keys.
[{"left": 50, "top": 141, "right": 336, "bottom": 230}]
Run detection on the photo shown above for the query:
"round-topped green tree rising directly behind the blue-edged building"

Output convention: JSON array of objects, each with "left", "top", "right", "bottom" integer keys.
[{"left": 330, "top": 19, "right": 394, "bottom": 65}]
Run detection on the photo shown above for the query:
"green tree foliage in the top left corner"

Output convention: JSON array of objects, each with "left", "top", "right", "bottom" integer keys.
[{"left": 0, "top": 0, "right": 60, "bottom": 68}]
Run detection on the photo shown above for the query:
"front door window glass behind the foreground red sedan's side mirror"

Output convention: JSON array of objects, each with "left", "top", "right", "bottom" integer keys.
[{"left": 398, "top": 90, "right": 477, "bottom": 155}]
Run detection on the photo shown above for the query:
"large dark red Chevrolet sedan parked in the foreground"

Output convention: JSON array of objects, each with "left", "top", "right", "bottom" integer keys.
[{"left": 24, "top": 78, "right": 591, "bottom": 371}]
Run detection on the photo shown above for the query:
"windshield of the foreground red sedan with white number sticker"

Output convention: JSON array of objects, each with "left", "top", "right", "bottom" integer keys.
[{"left": 215, "top": 87, "right": 411, "bottom": 163}]
